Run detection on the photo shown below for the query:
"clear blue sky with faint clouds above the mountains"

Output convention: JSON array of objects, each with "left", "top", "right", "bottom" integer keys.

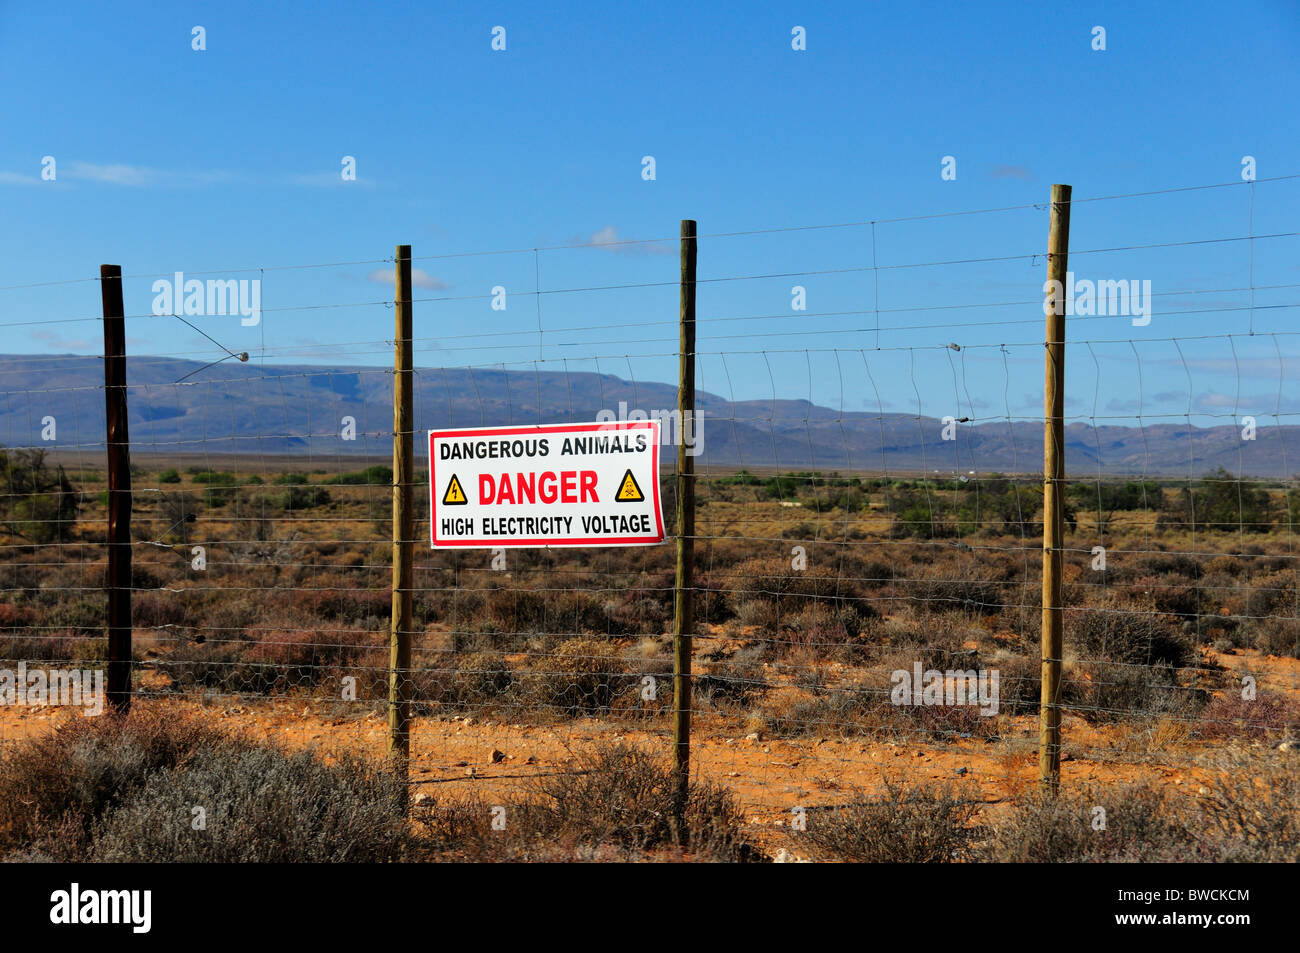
[{"left": 0, "top": 0, "right": 1300, "bottom": 423}]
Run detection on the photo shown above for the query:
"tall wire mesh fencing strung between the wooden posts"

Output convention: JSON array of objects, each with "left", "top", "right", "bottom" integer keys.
[{"left": 0, "top": 177, "right": 1300, "bottom": 824}]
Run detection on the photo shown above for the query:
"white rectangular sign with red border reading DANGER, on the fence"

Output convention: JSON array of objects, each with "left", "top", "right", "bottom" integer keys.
[{"left": 429, "top": 420, "right": 664, "bottom": 549}]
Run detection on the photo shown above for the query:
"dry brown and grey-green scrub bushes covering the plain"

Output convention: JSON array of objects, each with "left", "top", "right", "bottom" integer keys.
[{"left": 0, "top": 460, "right": 1300, "bottom": 862}]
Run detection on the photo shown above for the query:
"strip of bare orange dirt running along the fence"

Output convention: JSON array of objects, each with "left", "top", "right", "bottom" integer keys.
[{"left": 0, "top": 642, "right": 1300, "bottom": 852}]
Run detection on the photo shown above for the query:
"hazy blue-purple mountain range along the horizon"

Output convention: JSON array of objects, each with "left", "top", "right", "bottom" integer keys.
[{"left": 0, "top": 355, "right": 1300, "bottom": 477}]
